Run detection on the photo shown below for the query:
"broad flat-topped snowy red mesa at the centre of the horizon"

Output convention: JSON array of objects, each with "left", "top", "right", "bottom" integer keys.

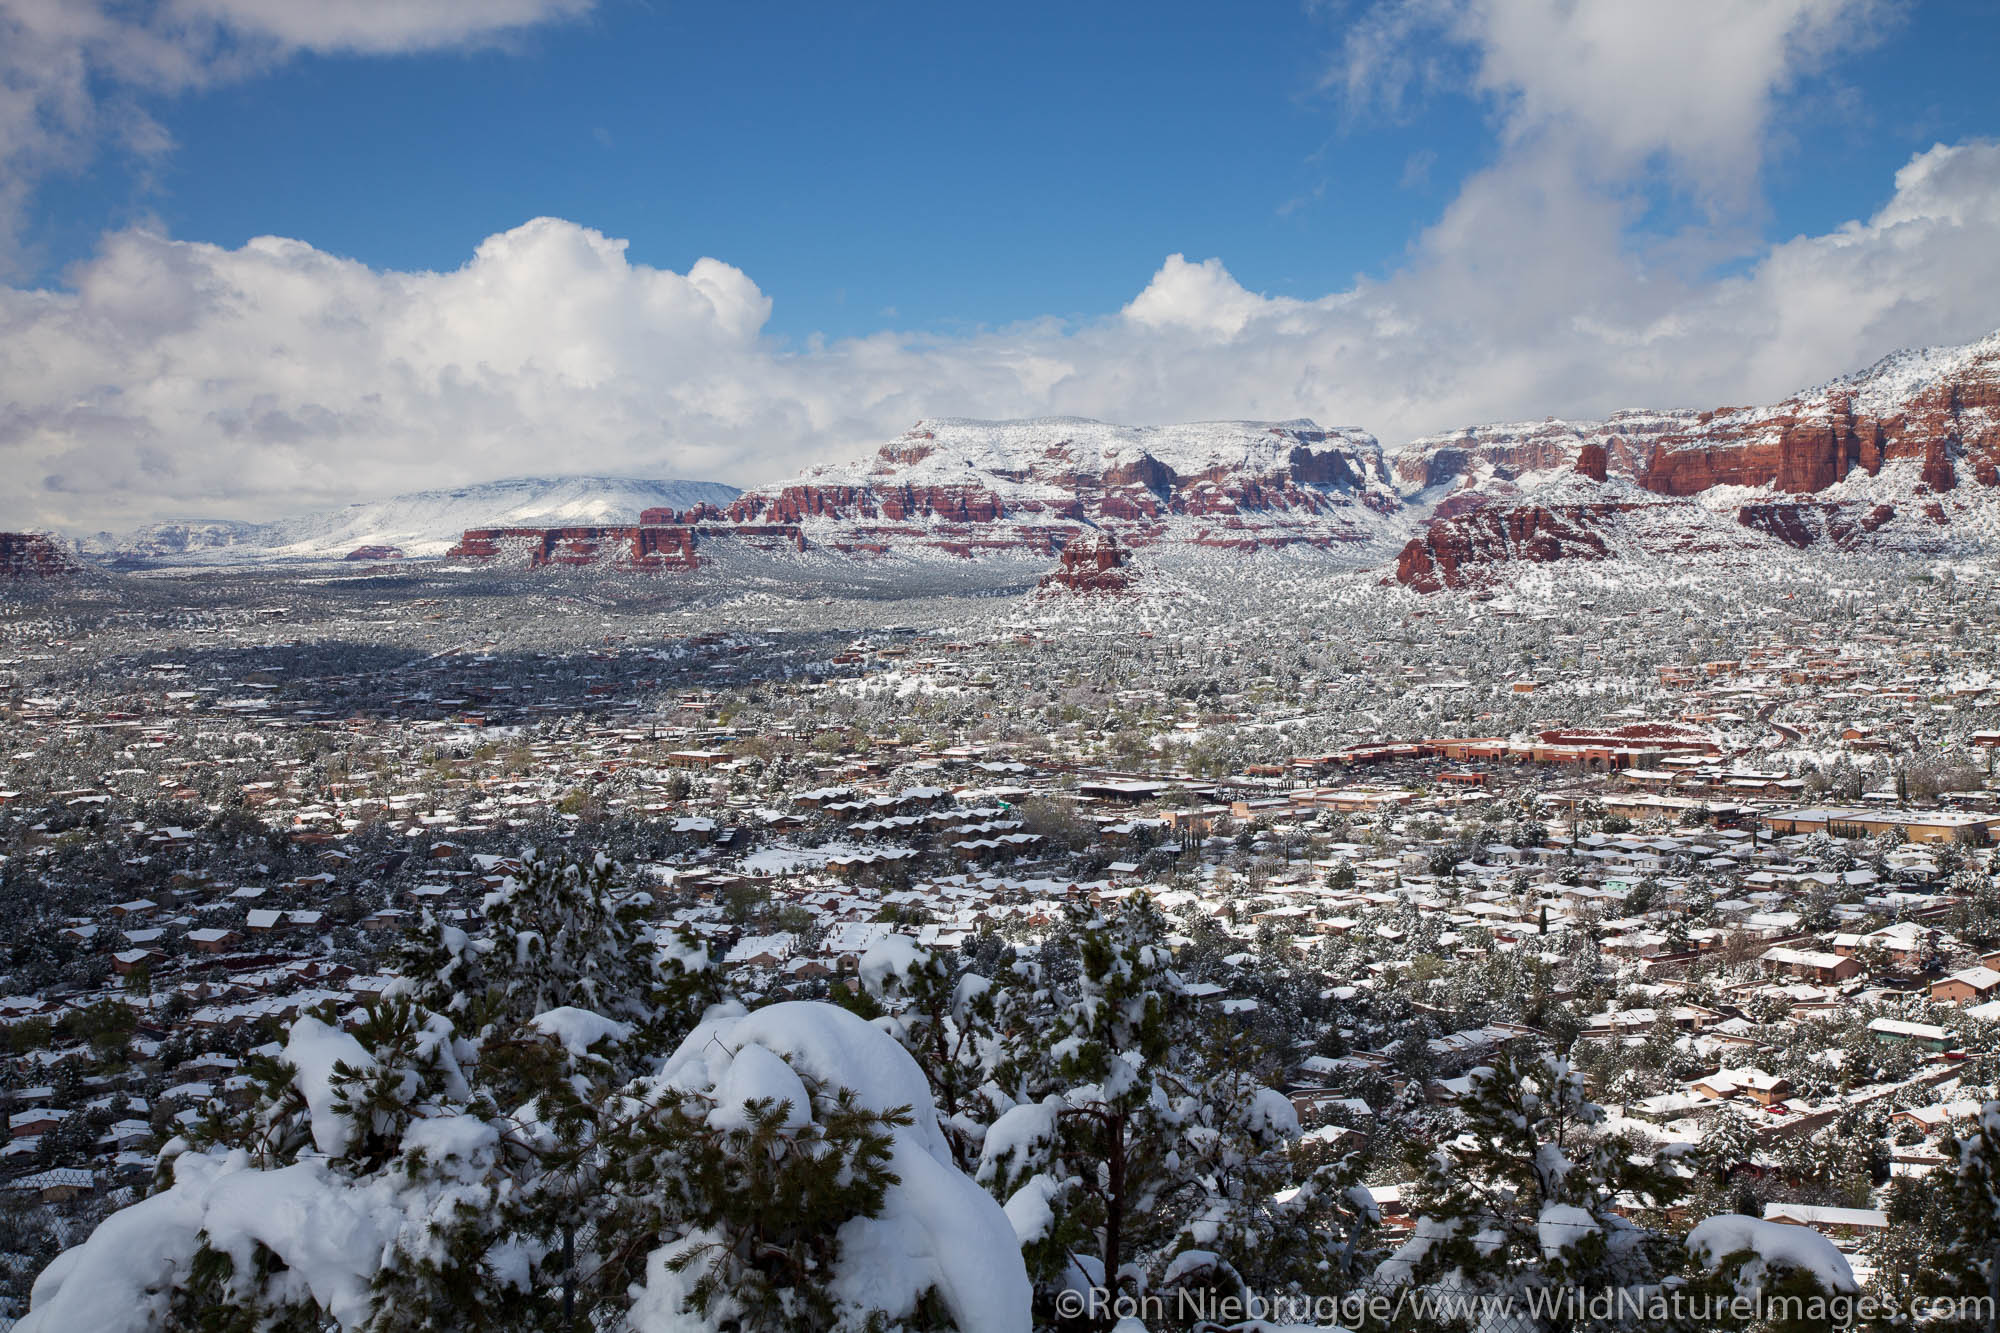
[{"left": 674, "top": 416, "right": 1402, "bottom": 556}]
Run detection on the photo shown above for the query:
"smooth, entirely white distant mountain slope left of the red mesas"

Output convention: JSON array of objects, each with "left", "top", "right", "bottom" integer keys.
[{"left": 80, "top": 476, "right": 740, "bottom": 564}]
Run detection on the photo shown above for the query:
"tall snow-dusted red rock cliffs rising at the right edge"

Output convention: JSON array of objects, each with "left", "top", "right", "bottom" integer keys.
[{"left": 1396, "top": 334, "right": 2000, "bottom": 592}]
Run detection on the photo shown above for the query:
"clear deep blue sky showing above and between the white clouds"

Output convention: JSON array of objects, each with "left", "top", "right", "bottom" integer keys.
[{"left": 30, "top": 0, "right": 2000, "bottom": 338}]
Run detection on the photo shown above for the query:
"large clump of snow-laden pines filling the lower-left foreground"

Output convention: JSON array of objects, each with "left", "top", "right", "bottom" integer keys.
[{"left": 20, "top": 852, "right": 1030, "bottom": 1333}]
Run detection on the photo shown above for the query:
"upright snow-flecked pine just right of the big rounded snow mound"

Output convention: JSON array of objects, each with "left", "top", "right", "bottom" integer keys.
[{"left": 978, "top": 897, "right": 1328, "bottom": 1313}]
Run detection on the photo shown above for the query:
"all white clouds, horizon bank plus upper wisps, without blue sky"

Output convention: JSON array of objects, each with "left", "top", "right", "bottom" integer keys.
[{"left": 0, "top": 0, "right": 2000, "bottom": 530}]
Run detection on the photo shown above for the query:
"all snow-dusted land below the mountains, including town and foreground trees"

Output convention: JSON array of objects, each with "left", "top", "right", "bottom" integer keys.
[{"left": 0, "top": 500, "right": 2000, "bottom": 1333}]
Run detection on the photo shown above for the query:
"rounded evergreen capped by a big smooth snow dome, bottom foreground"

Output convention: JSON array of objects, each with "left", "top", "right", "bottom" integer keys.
[{"left": 600, "top": 1001, "right": 1030, "bottom": 1333}]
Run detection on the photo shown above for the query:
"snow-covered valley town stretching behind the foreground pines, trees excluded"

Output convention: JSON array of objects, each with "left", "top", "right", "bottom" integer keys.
[{"left": 0, "top": 536, "right": 2000, "bottom": 1327}]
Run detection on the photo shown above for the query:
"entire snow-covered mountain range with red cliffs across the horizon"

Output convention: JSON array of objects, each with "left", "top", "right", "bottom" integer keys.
[{"left": 82, "top": 334, "right": 2000, "bottom": 586}]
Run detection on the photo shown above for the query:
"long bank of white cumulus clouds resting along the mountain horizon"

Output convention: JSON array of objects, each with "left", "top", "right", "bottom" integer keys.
[{"left": 0, "top": 142, "right": 2000, "bottom": 530}]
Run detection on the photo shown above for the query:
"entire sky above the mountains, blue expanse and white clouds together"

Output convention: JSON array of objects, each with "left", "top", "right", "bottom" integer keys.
[{"left": 0, "top": 0, "right": 2000, "bottom": 528}]
